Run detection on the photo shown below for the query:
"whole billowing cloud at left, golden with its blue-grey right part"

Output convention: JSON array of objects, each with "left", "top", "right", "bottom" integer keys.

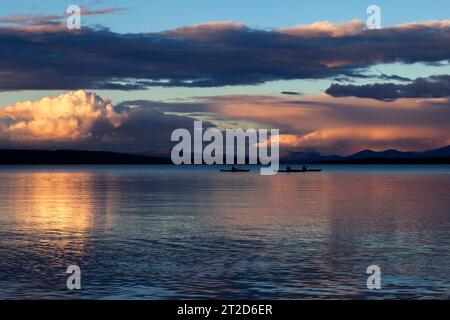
[{"left": 0, "top": 90, "right": 204, "bottom": 151}]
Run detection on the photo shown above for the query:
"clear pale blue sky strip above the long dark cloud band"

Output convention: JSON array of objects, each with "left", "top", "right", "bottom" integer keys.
[{"left": 0, "top": 0, "right": 450, "bottom": 33}]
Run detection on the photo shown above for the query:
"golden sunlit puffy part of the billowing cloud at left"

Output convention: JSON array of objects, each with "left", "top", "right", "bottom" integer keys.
[{"left": 0, "top": 91, "right": 126, "bottom": 142}]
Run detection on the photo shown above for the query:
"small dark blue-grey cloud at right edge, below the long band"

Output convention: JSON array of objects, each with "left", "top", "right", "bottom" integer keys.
[{"left": 326, "top": 75, "right": 450, "bottom": 100}]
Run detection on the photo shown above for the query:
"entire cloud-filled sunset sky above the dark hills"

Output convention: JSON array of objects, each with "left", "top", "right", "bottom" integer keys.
[{"left": 0, "top": 0, "right": 450, "bottom": 155}]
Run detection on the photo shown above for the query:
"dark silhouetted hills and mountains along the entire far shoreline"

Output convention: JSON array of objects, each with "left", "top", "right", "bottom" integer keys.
[{"left": 0, "top": 146, "right": 450, "bottom": 165}]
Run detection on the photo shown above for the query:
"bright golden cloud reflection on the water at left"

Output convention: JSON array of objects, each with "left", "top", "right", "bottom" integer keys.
[{"left": 9, "top": 172, "right": 113, "bottom": 254}]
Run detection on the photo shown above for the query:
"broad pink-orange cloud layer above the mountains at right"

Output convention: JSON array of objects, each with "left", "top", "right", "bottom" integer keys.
[{"left": 135, "top": 95, "right": 450, "bottom": 154}]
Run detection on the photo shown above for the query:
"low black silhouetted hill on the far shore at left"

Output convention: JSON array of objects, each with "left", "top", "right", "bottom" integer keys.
[{"left": 0, "top": 150, "right": 171, "bottom": 165}]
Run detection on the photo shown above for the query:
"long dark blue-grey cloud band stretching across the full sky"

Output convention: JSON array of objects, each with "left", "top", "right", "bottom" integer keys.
[{"left": 0, "top": 21, "right": 450, "bottom": 90}]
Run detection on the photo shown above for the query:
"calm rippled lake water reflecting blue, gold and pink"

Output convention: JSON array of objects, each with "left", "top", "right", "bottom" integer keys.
[{"left": 0, "top": 166, "right": 450, "bottom": 299}]
